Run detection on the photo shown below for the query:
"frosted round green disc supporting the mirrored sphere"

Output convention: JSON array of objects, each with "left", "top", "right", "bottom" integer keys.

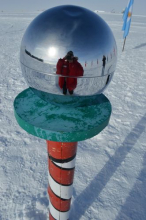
[{"left": 14, "top": 89, "right": 111, "bottom": 142}]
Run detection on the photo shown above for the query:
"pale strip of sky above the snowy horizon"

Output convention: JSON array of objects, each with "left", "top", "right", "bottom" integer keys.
[{"left": 0, "top": 0, "right": 146, "bottom": 15}]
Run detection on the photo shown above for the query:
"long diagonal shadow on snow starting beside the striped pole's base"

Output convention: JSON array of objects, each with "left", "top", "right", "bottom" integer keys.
[{"left": 70, "top": 114, "right": 146, "bottom": 219}]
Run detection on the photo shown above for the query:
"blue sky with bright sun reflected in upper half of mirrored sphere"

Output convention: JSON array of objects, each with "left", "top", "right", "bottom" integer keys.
[{"left": 23, "top": 6, "right": 115, "bottom": 64}]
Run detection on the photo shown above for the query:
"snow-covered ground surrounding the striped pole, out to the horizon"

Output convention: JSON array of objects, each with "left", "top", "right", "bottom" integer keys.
[{"left": 0, "top": 13, "right": 146, "bottom": 220}]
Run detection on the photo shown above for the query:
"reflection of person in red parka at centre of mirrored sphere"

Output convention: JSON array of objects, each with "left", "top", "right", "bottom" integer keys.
[{"left": 56, "top": 51, "right": 84, "bottom": 95}]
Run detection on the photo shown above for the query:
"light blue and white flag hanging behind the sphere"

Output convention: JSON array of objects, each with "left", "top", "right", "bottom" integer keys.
[{"left": 122, "top": 0, "right": 134, "bottom": 38}]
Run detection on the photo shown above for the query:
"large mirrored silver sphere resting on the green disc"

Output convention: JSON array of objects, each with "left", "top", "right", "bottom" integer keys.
[{"left": 20, "top": 5, "right": 117, "bottom": 100}]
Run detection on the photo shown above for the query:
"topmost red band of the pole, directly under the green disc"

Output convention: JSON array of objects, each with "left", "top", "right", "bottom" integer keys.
[{"left": 47, "top": 140, "right": 77, "bottom": 160}]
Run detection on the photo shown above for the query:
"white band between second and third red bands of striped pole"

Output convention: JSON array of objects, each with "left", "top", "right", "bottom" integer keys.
[{"left": 48, "top": 174, "right": 73, "bottom": 199}]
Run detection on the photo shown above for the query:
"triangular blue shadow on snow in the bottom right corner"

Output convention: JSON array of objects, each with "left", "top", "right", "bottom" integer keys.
[{"left": 116, "top": 153, "right": 146, "bottom": 220}]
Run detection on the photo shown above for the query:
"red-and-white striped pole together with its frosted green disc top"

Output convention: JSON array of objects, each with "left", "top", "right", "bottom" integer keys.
[{"left": 14, "top": 89, "right": 111, "bottom": 220}]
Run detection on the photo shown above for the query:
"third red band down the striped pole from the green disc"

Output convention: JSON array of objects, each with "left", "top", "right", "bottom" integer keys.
[{"left": 48, "top": 186, "right": 71, "bottom": 212}]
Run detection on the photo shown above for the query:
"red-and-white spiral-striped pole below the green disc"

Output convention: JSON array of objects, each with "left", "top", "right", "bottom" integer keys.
[{"left": 47, "top": 140, "right": 77, "bottom": 220}]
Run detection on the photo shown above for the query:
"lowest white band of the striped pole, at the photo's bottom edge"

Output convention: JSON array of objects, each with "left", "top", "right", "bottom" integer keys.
[{"left": 49, "top": 201, "right": 70, "bottom": 220}]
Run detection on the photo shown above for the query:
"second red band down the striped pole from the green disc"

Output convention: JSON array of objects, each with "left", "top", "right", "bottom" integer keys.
[{"left": 48, "top": 159, "right": 74, "bottom": 185}]
